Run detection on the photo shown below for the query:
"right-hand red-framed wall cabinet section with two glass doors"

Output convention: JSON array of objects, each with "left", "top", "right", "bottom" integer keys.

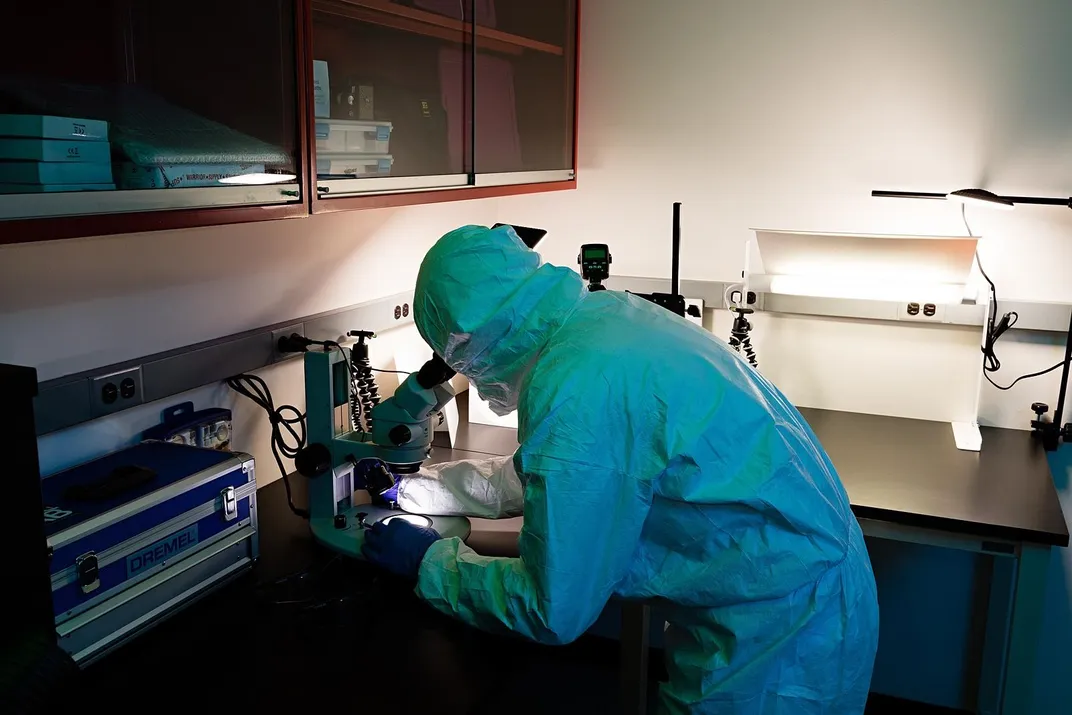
[{"left": 310, "top": 0, "right": 577, "bottom": 210}]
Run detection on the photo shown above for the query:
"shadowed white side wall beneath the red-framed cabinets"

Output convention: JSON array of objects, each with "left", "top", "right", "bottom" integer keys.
[{"left": 0, "top": 202, "right": 496, "bottom": 483}]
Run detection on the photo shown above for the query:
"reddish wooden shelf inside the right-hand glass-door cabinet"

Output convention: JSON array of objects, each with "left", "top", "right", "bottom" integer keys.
[{"left": 313, "top": 0, "right": 565, "bottom": 56}]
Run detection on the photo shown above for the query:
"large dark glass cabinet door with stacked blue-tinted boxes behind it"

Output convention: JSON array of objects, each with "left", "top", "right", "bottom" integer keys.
[{"left": 0, "top": 0, "right": 303, "bottom": 221}]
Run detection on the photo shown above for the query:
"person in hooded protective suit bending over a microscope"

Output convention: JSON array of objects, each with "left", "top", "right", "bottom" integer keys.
[{"left": 364, "top": 226, "right": 878, "bottom": 715}]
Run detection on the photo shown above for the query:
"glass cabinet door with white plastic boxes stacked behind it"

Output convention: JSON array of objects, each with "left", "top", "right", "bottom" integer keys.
[{"left": 312, "top": 0, "right": 474, "bottom": 200}]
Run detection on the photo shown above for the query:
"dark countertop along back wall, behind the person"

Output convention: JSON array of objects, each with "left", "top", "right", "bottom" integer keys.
[{"left": 433, "top": 408, "right": 1069, "bottom": 551}]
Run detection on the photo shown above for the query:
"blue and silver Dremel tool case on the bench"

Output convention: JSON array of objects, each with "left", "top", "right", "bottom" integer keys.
[{"left": 42, "top": 442, "right": 257, "bottom": 665}]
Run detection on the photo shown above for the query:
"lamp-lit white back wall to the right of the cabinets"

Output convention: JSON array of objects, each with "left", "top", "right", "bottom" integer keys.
[{"left": 501, "top": 0, "right": 1072, "bottom": 429}]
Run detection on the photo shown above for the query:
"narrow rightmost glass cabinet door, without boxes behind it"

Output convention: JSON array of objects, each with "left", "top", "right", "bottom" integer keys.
[{"left": 473, "top": 0, "right": 577, "bottom": 185}]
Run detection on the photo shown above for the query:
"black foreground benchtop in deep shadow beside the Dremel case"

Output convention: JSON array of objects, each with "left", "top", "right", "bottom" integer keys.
[{"left": 83, "top": 469, "right": 634, "bottom": 715}]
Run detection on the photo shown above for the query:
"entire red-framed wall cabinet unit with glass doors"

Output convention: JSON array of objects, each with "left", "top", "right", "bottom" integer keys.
[{"left": 0, "top": 0, "right": 579, "bottom": 243}]
